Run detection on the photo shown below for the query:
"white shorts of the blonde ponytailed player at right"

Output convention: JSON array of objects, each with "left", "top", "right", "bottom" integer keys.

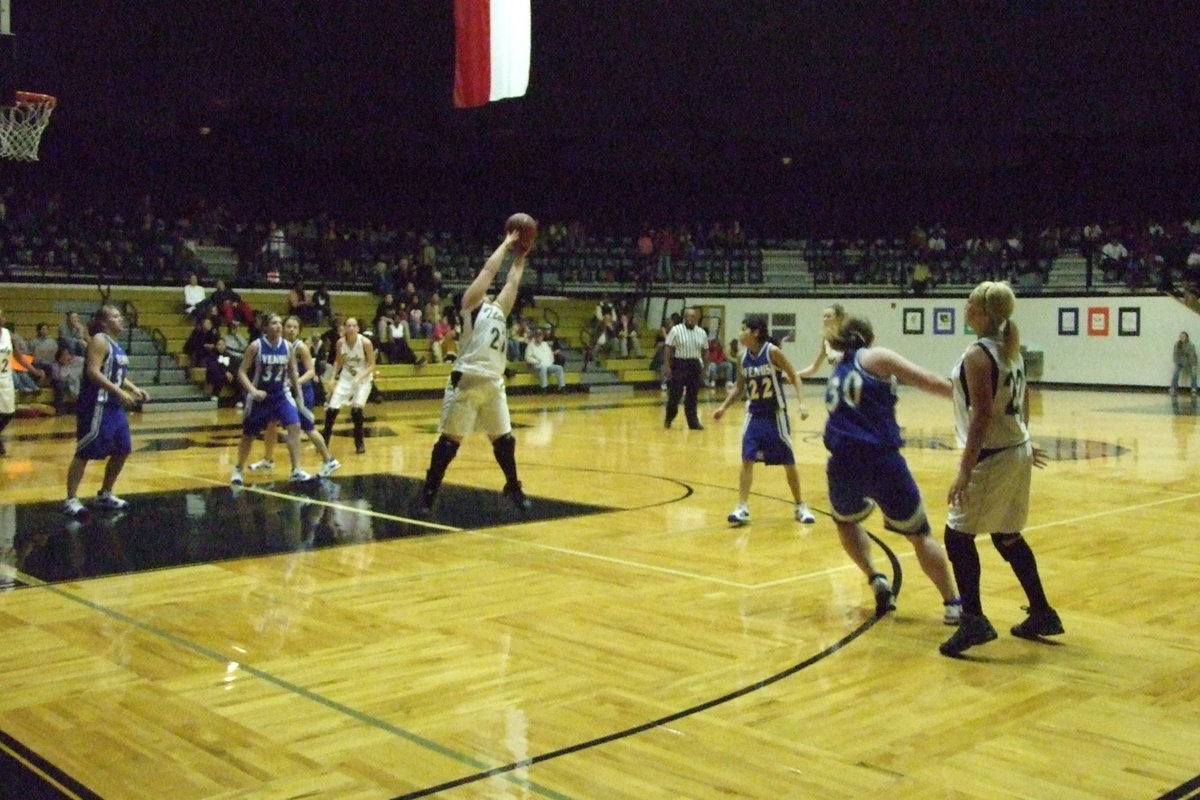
[{"left": 946, "top": 441, "right": 1033, "bottom": 534}]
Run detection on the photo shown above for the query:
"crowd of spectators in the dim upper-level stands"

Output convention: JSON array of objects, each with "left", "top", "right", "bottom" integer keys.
[{"left": 0, "top": 188, "right": 1200, "bottom": 299}]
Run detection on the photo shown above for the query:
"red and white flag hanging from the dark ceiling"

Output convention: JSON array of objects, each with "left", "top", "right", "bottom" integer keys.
[{"left": 454, "top": 0, "right": 530, "bottom": 108}]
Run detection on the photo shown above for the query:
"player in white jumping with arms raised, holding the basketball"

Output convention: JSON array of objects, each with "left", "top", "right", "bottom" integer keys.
[{"left": 418, "top": 229, "right": 532, "bottom": 516}]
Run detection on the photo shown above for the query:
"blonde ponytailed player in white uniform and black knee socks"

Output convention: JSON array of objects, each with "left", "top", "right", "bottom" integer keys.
[{"left": 938, "top": 281, "right": 1063, "bottom": 656}]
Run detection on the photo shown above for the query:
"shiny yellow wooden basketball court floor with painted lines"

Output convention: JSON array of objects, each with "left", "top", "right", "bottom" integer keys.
[{"left": 0, "top": 386, "right": 1200, "bottom": 800}]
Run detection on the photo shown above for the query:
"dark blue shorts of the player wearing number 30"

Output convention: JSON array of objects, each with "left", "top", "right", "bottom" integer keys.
[{"left": 826, "top": 446, "right": 929, "bottom": 535}]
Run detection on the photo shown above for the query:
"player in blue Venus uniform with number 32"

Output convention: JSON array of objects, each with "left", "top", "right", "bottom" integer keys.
[{"left": 229, "top": 314, "right": 312, "bottom": 486}]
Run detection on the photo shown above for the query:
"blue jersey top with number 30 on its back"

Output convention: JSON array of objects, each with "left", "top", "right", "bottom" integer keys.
[{"left": 824, "top": 349, "right": 902, "bottom": 451}]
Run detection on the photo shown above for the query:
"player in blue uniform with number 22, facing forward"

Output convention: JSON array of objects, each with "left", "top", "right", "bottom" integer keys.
[{"left": 713, "top": 317, "right": 816, "bottom": 525}]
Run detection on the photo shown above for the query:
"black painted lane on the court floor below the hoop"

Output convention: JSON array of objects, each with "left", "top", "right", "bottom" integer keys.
[{"left": 0, "top": 475, "right": 607, "bottom": 588}]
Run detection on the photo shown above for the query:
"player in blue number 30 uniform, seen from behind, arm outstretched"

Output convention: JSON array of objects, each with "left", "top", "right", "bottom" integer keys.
[{"left": 824, "top": 314, "right": 962, "bottom": 625}]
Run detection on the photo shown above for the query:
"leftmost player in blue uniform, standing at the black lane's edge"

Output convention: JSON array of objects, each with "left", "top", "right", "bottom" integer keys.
[{"left": 62, "top": 306, "right": 150, "bottom": 517}]
